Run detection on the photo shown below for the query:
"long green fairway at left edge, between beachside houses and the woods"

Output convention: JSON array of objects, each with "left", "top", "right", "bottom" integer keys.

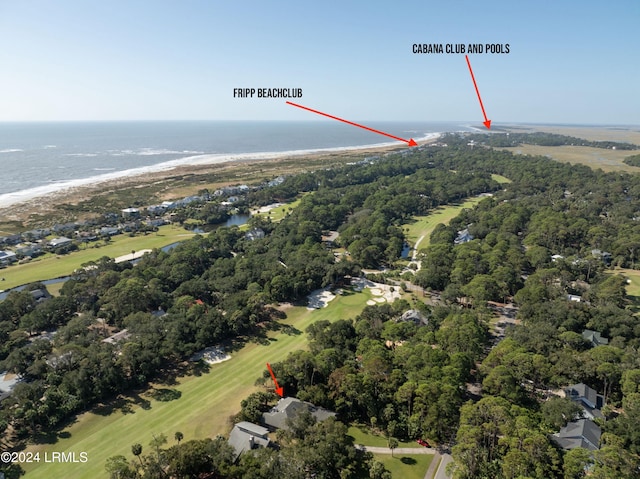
[{"left": 0, "top": 225, "right": 193, "bottom": 289}]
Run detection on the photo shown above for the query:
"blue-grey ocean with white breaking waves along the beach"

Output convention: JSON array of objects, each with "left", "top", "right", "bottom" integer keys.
[{"left": 0, "top": 121, "right": 475, "bottom": 207}]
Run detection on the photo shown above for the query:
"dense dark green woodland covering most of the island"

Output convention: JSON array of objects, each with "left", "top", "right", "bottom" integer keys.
[{"left": 0, "top": 135, "right": 640, "bottom": 479}]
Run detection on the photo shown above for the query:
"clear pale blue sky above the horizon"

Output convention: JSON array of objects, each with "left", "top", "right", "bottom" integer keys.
[{"left": 0, "top": 0, "right": 640, "bottom": 124}]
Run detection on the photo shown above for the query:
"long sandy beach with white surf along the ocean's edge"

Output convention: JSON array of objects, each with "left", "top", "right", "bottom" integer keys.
[{"left": 0, "top": 132, "right": 443, "bottom": 227}]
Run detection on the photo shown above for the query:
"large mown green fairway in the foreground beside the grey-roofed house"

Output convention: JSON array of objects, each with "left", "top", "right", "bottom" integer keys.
[{"left": 25, "top": 290, "right": 371, "bottom": 479}]
